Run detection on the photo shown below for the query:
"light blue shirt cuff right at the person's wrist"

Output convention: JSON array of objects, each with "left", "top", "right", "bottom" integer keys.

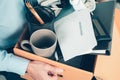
[{"left": 7, "top": 55, "right": 30, "bottom": 75}]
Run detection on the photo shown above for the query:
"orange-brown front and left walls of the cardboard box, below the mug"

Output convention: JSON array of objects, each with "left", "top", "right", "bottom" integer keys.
[{"left": 14, "top": 24, "right": 93, "bottom": 80}]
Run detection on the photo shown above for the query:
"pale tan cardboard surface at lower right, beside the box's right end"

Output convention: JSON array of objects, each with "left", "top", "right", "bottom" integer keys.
[{"left": 94, "top": 9, "right": 120, "bottom": 80}]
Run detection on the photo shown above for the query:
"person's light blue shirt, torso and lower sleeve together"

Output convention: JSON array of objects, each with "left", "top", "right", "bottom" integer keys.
[{"left": 0, "top": 0, "right": 29, "bottom": 75}]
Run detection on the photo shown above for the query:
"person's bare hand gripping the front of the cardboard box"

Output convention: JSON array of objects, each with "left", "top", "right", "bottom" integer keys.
[{"left": 27, "top": 61, "right": 63, "bottom": 80}]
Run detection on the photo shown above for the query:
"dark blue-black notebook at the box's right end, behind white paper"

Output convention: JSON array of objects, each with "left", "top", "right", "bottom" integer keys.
[{"left": 92, "top": 1, "right": 115, "bottom": 54}]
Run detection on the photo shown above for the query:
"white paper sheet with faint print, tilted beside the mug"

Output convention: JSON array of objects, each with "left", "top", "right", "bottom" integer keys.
[{"left": 54, "top": 10, "right": 97, "bottom": 61}]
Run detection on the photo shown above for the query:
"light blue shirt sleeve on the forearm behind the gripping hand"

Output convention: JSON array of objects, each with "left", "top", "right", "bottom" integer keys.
[{"left": 0, "top": 50, "right": 29, "bottom": 75}]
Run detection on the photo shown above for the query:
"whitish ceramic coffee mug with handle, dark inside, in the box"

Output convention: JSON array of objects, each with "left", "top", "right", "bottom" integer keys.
[{"left": 21, "top": 29, "right": 57, "bottom": 57}]
